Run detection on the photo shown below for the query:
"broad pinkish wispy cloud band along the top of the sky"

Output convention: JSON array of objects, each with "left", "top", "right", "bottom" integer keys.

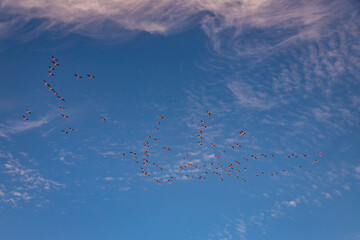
[{"left": 0, "top": 0, "right": 352, "bottom": 49}]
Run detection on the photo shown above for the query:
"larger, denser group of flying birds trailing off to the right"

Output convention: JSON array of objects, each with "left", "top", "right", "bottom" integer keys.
[{"left": 117, "top": 111, "right": 324, "bottom": 184}]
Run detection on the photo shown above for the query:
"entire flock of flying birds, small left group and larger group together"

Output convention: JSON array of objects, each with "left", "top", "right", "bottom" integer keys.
[{"left": 22, "top": 56, "right": 324, "bottom": 184}]
